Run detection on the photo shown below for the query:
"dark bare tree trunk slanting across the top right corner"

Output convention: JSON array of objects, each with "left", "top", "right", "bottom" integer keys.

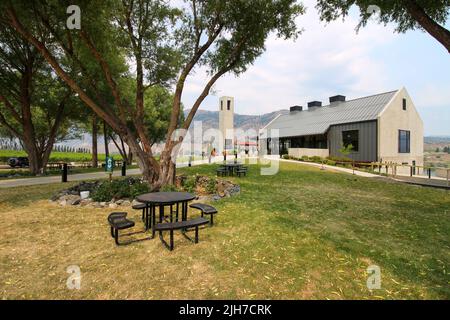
[{"left": 404, "top": 0, "right": 450, "bottom": 53}]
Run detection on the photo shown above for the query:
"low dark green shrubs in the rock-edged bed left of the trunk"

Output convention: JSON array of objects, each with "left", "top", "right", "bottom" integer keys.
[{"left": 92, "top": 178, "right": 150, "bottom": 202}]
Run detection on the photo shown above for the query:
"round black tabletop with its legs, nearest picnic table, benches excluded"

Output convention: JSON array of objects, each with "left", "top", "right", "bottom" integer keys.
[{"left": 136, "top": 192, "right": 196, "bottom": 235}]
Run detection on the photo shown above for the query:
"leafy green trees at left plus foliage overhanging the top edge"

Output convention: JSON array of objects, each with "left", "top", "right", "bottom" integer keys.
[{"left": 0, "top": 0, "right": 450, "bottom": 190}]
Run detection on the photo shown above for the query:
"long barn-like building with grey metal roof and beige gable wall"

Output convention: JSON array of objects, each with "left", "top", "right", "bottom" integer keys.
[{"left": 261, "top": 88, "right": 423, "bottom": 166}]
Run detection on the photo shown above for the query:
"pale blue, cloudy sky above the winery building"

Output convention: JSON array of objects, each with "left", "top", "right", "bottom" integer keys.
[{"left": 182, "top": 0, "right": 450, "bottom": 135}]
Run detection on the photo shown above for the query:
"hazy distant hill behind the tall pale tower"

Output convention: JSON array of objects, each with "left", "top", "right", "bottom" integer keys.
[{"left": 184, "top": 110, "right": 287, "bottom": 131}]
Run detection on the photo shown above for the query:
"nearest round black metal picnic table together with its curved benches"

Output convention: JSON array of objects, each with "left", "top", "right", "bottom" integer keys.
[{"left": 108, "top": 192, "right": 218, "bottom": 251}]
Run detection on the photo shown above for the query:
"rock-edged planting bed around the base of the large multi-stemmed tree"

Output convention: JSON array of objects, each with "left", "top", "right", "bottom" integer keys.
[{"left": 50, "top": 175, "right": 241, "bottom": 209}]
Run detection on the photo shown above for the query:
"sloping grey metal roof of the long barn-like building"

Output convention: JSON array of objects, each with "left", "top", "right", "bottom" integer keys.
[{"left": 266, "top": 90, "right": 398, "bottom": 137}]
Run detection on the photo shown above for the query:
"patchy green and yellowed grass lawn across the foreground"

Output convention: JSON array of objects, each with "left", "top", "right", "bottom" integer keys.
[{"left": 0, "top": 163, "right": 450, "bottom": 299}]
